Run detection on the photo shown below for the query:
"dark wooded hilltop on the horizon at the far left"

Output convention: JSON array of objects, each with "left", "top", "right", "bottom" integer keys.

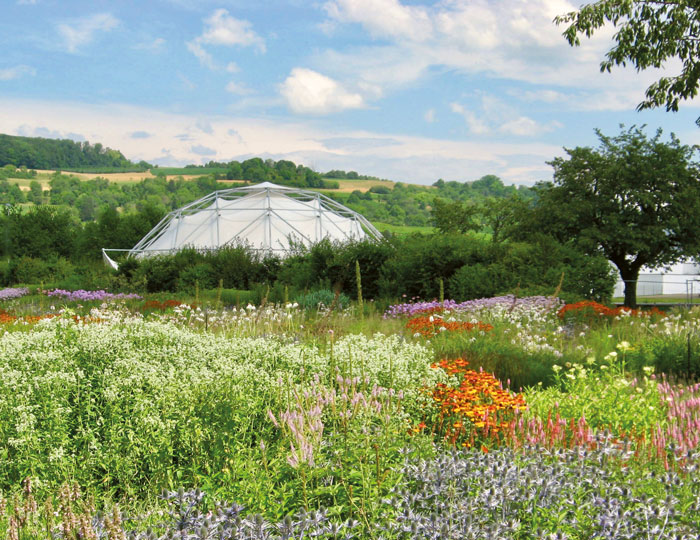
[{"left": 0, "top": 134, "right": 150, "bottom": 170}]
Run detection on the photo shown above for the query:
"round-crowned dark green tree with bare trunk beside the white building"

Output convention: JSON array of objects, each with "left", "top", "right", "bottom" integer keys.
[{"left": 536, "top": 126, "right": 700, "bottom": 307}]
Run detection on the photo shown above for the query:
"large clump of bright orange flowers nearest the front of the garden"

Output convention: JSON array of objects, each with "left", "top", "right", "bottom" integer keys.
[{"left": 415, "top": 358, "right": 525, "bottom": 449}]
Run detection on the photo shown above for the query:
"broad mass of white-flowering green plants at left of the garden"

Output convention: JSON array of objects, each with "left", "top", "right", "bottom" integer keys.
[{"left": 0, "top": 318, "right": 440, "bottom": 515}]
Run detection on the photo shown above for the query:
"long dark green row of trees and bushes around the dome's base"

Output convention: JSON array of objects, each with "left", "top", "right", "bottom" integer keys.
[{"left": 0, "top": 205, "right": 615, "bottom": 301}]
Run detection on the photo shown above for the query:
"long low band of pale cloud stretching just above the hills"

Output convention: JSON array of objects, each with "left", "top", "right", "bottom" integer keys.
[{"left": 0, "top": 97, "right": 564, "bottom": 184}]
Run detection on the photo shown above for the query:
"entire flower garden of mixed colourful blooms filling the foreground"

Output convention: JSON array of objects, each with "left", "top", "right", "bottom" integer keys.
[{"left": 0, "top": 289, "right": 700, "bottom": 540}]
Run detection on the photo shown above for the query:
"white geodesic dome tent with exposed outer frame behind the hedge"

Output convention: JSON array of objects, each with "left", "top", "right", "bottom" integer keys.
[{"left": 102, "top": 182, "right": 381, "bottom": 267}]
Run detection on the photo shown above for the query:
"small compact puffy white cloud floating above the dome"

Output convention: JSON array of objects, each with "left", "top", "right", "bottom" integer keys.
[{"left": 280, "top": 68, "right": 365, "bottom": 114}]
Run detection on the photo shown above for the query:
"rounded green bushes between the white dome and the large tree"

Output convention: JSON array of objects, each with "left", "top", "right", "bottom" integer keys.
[{"left": 379, "top": 235, "right": 615, "bottom": 301}]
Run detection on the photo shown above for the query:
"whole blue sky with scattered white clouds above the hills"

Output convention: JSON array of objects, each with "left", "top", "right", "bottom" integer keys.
[{"left": 0, "top": 0, "right": 700, "bottom": 185}]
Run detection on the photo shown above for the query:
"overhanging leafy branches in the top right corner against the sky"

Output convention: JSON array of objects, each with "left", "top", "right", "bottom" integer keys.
[{"left": 554, "top": 0, "right": 700, "bottom": 125}]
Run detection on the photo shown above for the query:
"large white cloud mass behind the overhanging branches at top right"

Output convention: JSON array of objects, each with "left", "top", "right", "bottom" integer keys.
[{"left": 315, "top": 0, "right": 680, "bottom": 110}]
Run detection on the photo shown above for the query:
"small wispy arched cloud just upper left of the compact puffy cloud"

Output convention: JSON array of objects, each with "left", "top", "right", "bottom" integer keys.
[{"left": 186, "top": 9, "right": 266, "bottom": 71}]
